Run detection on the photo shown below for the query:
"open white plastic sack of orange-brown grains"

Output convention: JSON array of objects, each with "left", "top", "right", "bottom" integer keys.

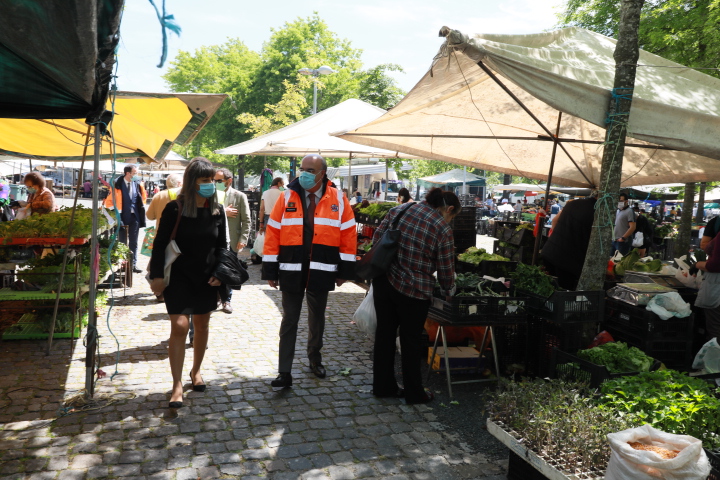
[{"left": 605, "top": 425, "right": 710, "bottom": 480}]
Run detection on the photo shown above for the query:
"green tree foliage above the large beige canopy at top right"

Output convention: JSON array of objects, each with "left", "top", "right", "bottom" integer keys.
[{"left": 559, "top": 0, "right": 720, "bottom": 76}]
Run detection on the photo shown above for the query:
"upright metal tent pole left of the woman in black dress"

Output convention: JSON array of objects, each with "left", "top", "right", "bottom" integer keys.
[{"left": 85, "top": 124, "right": 101, "bottom": 397}]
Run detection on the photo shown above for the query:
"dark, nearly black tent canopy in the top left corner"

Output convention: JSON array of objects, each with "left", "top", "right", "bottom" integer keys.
[{"left": 0, "top": 0, "right": 124, "bottom": 122}]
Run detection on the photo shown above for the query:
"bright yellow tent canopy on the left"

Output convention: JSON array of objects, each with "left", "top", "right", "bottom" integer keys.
[{"left": 0, "top": 92, "right": 227, "bottom": 162}]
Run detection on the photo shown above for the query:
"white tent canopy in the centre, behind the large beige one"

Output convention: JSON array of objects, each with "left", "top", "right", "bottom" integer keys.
[{"left": 215, "top": 98, "right": 415, "bottom": 158}]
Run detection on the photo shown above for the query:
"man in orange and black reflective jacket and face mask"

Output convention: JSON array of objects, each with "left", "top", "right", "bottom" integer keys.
[{"left": 262, "top": 155, "right": 357, "bottom": 388}]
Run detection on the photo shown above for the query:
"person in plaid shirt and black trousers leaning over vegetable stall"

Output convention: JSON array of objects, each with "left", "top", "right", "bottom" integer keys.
[{"left": 373, "top": 188, "right": 461, "bottom": 404}]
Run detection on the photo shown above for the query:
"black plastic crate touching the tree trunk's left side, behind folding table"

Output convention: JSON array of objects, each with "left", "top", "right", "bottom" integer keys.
[{"left": 518, "top": 290, "right": 605, "bottom": 323}]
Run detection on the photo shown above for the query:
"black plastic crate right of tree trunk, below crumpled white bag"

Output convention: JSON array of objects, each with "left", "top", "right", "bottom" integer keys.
[{"left": 605, "top": 298, "right": 694, "bottom": 340}]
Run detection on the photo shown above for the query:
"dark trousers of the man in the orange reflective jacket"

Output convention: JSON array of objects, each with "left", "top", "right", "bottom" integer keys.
[{"left": 278, "top": 291, "right": 328, "bottom": 373}]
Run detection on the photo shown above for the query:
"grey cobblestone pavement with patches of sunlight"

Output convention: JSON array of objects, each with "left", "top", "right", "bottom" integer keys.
[{"left": 0, "top": 238, "right": 507, "bottom": 480}]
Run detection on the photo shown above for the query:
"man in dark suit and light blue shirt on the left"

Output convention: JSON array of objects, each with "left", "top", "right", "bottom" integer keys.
[{"left": 105, "top": 165, "right": 147, "bottom": 273}]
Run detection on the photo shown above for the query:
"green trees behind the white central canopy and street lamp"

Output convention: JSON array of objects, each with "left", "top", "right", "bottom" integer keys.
[{"left": 163, "top": 13, "right": 404, "bottom": 174}]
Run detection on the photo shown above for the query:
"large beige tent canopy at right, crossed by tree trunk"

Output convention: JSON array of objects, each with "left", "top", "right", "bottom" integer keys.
[{"left": 336, "top": 28, "right": 720, "bottom": 187}]
